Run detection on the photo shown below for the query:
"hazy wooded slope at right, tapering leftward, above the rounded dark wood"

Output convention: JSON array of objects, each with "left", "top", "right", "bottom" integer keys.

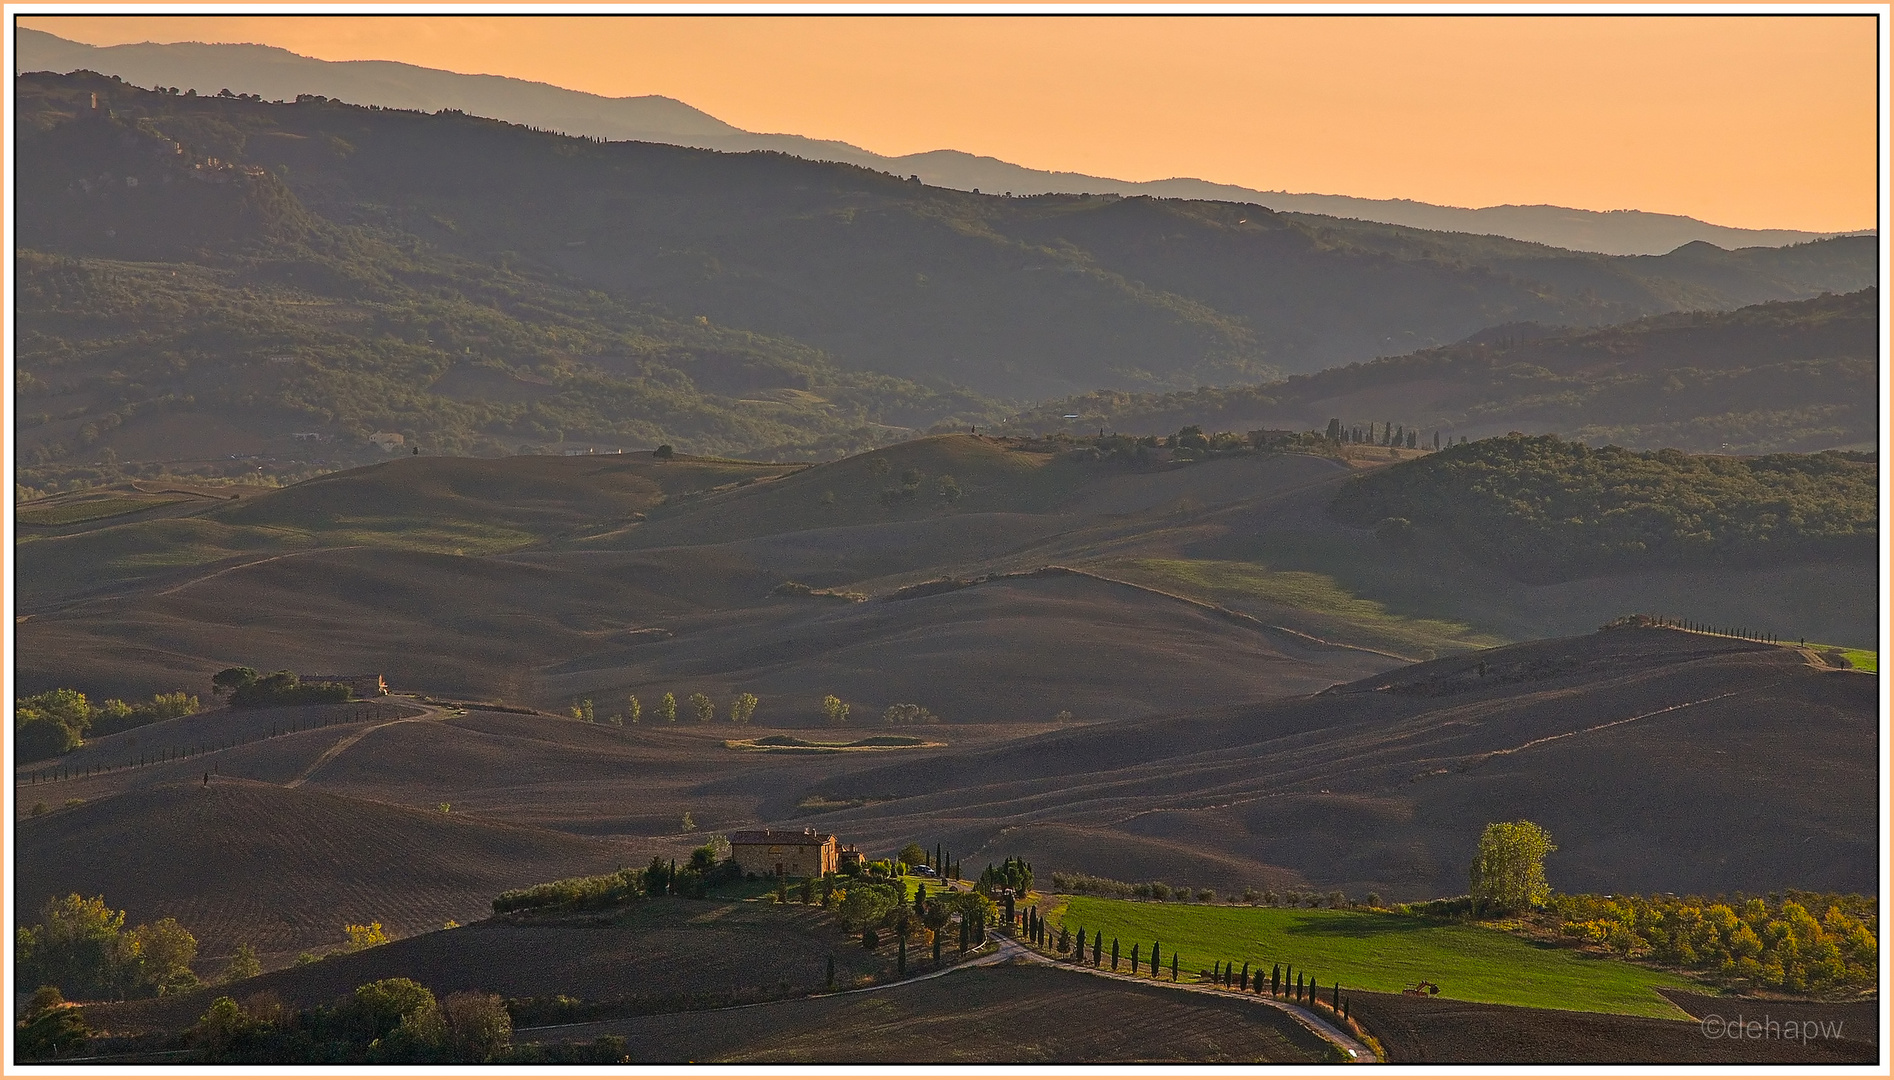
[{"left": 1010, "top": 286, "right": 1881, "bottom": 453}]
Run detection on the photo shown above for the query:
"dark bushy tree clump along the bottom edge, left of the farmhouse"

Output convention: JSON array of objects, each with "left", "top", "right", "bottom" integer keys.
[{"left": 186, "top": 978, "right": 513, "bottom": 1065}]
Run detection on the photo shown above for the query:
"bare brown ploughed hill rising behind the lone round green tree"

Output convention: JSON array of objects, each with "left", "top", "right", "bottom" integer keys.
[{"left": 787, "top": 629, "right": 1879, "bottom": 896}]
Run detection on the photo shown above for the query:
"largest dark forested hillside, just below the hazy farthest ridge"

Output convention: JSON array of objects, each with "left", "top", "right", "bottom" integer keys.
[{"left": 17, "top": 74, "right": 1873, "bottom": 485}]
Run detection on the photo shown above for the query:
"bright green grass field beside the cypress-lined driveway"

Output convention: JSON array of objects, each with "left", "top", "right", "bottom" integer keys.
[{"left": 1064, "top": 896, "right": 1706, "bottom": 1019}]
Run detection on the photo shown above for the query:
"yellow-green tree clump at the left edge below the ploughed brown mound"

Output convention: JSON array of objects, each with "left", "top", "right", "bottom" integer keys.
[{"left": 13, "top": 892, "right": 199, "bottom": 999}]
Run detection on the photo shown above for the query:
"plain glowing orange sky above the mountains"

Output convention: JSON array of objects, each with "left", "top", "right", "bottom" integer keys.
[{"left": 21, "top": 15, "right": 1879, "bottom": 231}]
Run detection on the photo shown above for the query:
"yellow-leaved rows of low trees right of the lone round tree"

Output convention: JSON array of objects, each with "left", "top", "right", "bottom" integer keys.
[{"left": 1549, "top": 892, "right": 1879, "bottom": 993}]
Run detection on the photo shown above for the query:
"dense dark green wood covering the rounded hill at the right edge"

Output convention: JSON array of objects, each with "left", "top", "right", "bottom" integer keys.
[{"left": 1330, "top": 434, "right": 1879, "bottom": 582}]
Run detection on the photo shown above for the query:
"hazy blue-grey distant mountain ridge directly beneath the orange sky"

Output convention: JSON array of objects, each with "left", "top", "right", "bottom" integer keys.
[{"left": 15, "top": 28, "right": 1858, "bottom": 254}]
